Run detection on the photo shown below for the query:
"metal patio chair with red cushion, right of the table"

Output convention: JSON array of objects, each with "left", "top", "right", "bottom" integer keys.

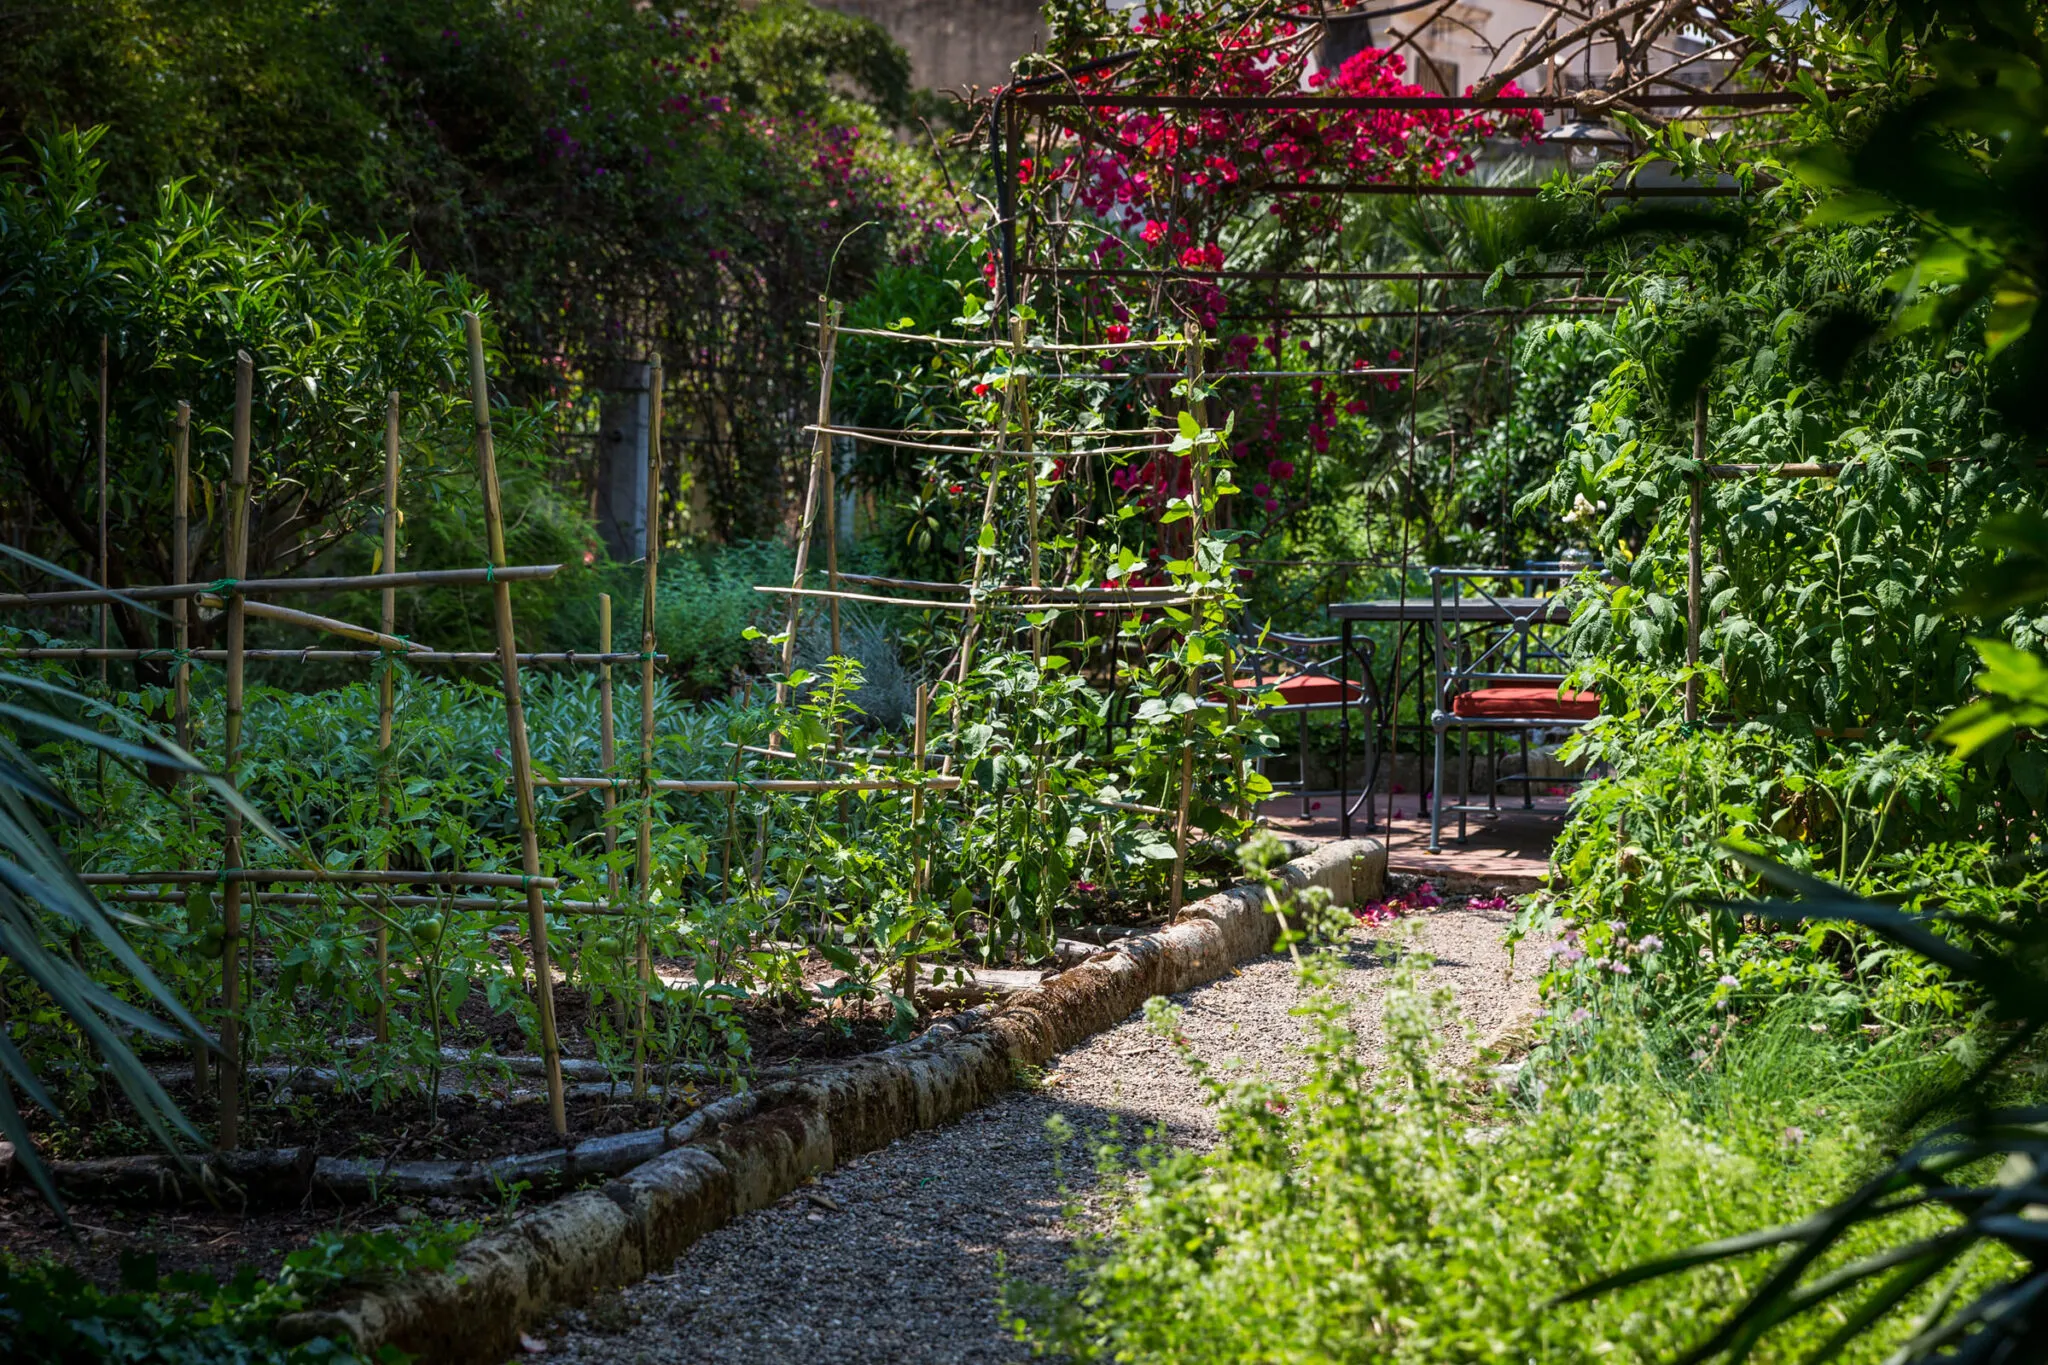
[{"left": 1430, "top": 565, "right": 1599, "bottom": 853}]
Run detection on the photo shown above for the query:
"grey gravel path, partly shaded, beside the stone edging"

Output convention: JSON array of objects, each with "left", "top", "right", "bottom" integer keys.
[{"left": 547, "top": 902, "right": 1534, "bottom": 1365}]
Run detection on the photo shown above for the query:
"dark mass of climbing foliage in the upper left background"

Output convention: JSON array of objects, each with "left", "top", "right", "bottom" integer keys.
[{"left": 0, "top": 0, "right": 965, "bottom": 534}]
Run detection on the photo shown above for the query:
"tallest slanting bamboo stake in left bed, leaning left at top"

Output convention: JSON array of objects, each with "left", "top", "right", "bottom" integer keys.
[{"left": 463, "top": 313, "right": 569, "bottom": 1136}]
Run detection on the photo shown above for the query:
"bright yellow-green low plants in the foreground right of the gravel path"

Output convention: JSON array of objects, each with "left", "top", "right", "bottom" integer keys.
[{"left": 1018, "top": 941, "right": 2011, "bottom": 1365}]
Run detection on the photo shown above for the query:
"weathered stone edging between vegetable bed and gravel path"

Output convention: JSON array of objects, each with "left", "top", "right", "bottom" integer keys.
[{"left": 279, "top": 839, "right": 1386, "bottom": 1365}]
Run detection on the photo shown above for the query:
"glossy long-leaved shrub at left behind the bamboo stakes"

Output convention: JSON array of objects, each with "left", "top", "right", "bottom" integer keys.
[{"left": 0, "top": 131, "right": 479, "bottom": 609}]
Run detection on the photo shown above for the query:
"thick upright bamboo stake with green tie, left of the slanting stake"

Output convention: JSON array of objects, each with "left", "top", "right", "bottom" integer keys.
[{"left": 219, "top": 350, "right": 256, "bottom": 1152}]
